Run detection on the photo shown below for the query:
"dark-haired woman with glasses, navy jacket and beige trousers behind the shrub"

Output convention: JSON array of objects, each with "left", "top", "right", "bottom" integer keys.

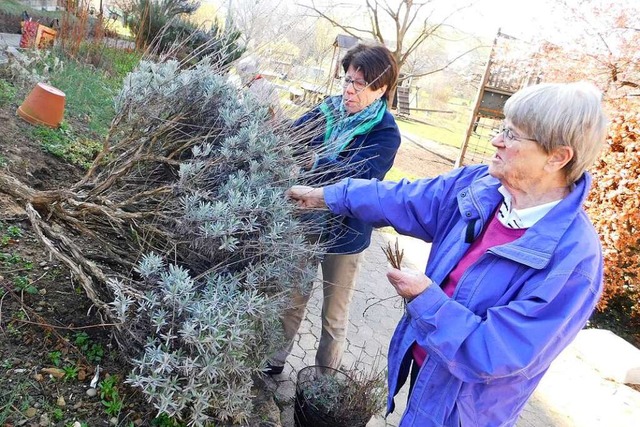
[{"left": 265, "top": 44, "right": 400, "bottom": 374}]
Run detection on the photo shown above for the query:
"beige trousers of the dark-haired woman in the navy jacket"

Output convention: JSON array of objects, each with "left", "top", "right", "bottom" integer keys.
[{"left": 271, "top": 252, "right": 363, "bottom": 368}]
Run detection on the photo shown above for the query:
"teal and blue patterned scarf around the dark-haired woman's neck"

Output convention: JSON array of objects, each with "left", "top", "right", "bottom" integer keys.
[{"left": 320, "top": 96, "right": 387, "bottom": 160}]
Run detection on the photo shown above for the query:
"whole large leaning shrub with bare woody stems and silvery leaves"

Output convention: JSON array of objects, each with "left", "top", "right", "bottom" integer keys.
[{"left": 0, "top": 56, "right": 321, "bottom": 426}]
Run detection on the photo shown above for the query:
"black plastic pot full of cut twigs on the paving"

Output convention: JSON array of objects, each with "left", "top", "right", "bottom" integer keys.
[{"left": 294, "top": 365, "right": 371, "bottom": 427}]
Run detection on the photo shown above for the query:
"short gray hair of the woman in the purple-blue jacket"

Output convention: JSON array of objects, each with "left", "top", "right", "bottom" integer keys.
[{"left": 504, "top": 82, "right": 607, "bottom": 184}]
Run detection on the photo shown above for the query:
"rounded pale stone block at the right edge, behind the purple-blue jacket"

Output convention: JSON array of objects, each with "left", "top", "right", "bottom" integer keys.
[{"left": 572, "top": 329, "right": 640, "bottom": 384}]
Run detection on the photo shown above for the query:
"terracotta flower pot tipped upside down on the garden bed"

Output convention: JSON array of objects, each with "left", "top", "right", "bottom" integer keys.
[{"left": 17, "top": 83, "right": 65, "bottom": 128}]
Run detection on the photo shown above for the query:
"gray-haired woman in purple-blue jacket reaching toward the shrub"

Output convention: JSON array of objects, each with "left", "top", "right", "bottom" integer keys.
[{"left": 289, "top": 83, "right": 606, "bottom": 427}]
